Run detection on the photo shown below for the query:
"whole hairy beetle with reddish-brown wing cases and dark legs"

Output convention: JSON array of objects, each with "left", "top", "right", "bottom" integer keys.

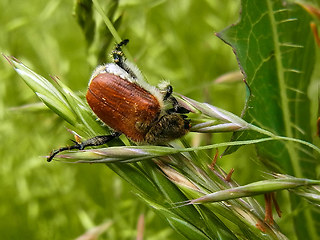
[{"left": 47, "top": 39, "right": 191, "bottom": 162}]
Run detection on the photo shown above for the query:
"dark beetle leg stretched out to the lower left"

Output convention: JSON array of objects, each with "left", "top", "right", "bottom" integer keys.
[{"left": 47, "top": 132, "right": 121, "bottom": 162}]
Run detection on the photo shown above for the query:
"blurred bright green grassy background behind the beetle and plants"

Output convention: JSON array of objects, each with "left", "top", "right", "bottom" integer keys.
[{"left": 0, "top": 0, "right": 306, "bottom": 240}]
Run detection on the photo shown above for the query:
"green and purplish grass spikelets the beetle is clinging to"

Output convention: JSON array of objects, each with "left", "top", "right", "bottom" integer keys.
[{"left": 6, "top": 54, "right": 320, "bottom": 239}]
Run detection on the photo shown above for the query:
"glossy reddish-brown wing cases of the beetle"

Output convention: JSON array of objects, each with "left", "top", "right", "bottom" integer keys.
[{"left": 86, "top": 72, "right": 161, "bottom": 142}]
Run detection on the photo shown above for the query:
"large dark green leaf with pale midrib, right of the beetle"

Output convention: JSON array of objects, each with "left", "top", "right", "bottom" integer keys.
[{"left": 218, "top": 0, "right": 319, "bottom": 239}]
